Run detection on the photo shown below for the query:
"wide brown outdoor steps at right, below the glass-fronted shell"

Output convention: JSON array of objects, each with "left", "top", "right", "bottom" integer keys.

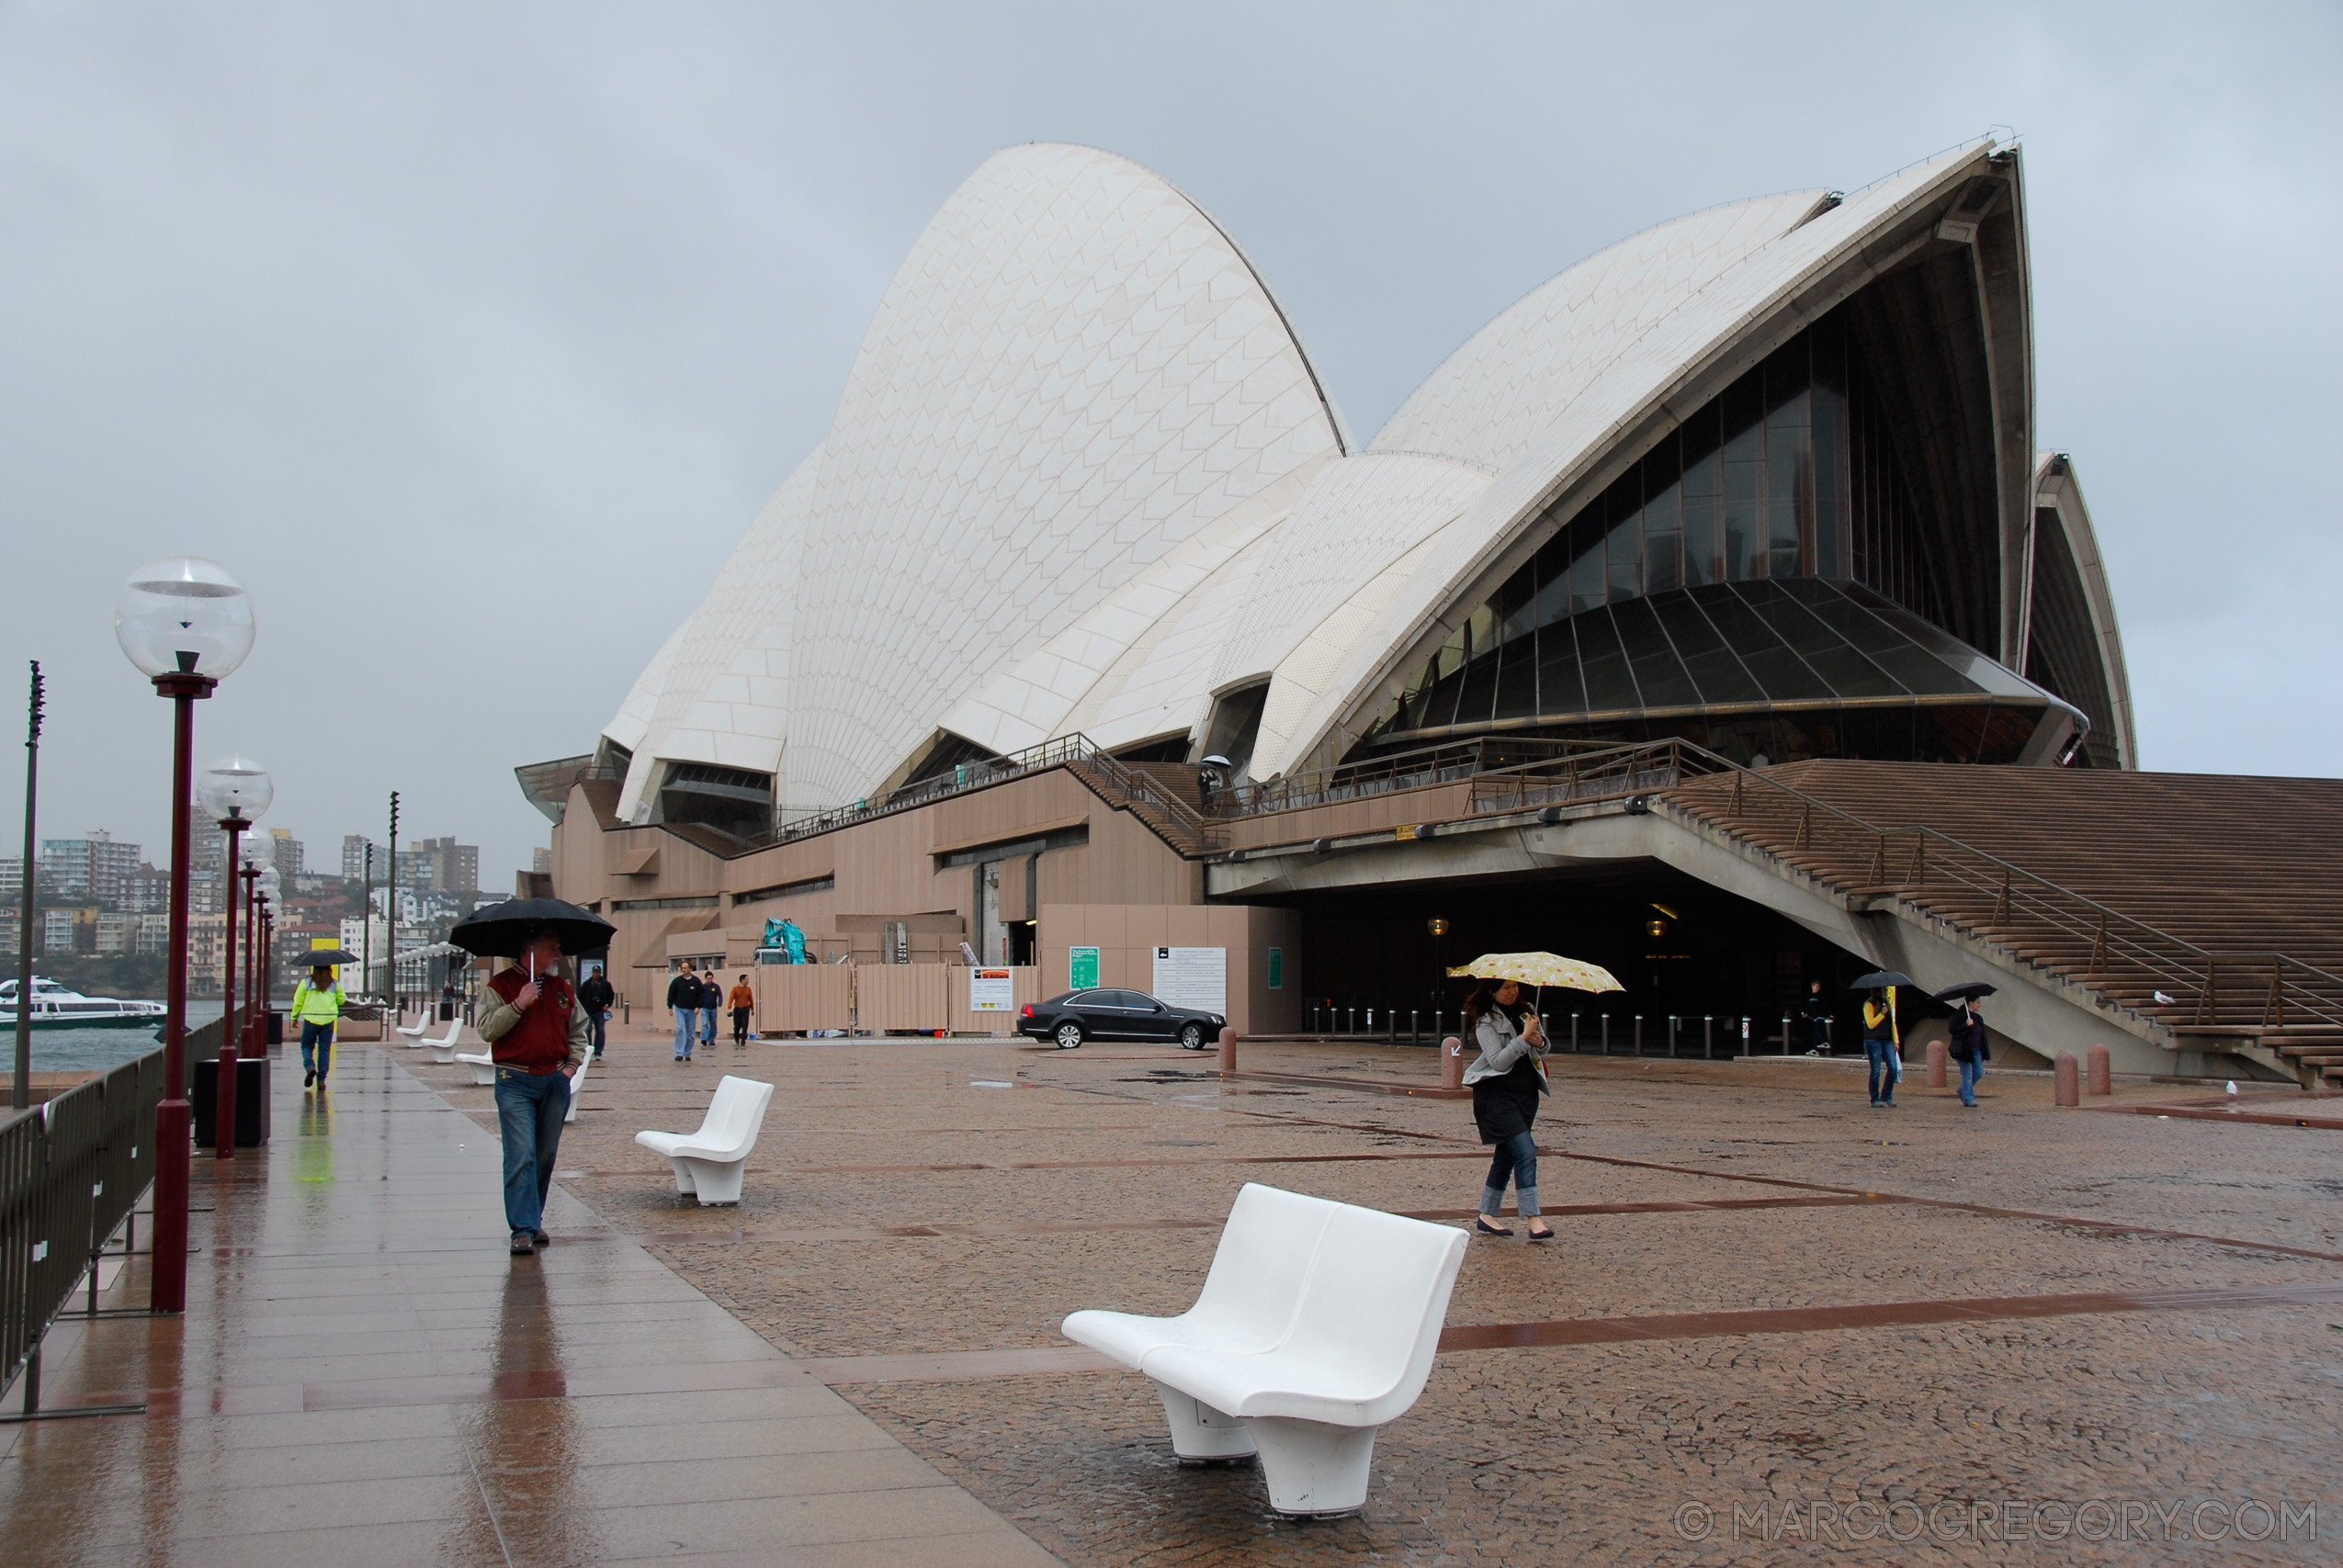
[{"left": 1664, "top": 761, "right": 2343, "bottom": 1050}]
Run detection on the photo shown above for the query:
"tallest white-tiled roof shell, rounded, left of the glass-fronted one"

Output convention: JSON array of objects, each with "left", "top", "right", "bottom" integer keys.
[{"left": 783, "top": 145, "right": 1341, "bottom": 808}]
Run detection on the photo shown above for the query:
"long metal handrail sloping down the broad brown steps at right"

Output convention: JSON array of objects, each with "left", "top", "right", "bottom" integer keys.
[{"left": 1687, "top": 759, "right": 2343, "bottom": 1027}]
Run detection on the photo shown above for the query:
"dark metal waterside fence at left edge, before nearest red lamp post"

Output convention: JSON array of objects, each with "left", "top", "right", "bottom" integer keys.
[{"left": 0, "top": 1050, "right": 164, "bottom": 1420}]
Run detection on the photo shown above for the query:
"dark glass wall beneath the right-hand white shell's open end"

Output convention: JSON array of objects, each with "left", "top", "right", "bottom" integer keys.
[{"left": 1362, "top": 307, "right": 2053, "bottom": 760}]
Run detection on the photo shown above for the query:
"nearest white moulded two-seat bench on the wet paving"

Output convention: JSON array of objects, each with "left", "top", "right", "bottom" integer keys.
[{"left": 1064, "top": 1184, "right": 1465, "bottom": 1514}]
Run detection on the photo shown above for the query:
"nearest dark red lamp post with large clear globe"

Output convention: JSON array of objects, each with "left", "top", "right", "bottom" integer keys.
[{"left": 115, "top": 556, "right": 253, "bottom": 1313}]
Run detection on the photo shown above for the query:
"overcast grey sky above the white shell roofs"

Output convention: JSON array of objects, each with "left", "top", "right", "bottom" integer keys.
[{"left": 0, "top": 0, "right": 2343, "bottom": 888}]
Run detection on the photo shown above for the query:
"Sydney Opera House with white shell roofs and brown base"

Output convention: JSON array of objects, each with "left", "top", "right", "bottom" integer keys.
[{"left": 520, "top": 141, "right": 2324, "bottom": 1082}]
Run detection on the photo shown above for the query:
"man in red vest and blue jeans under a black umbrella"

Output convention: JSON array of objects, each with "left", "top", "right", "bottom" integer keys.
[{"left": 476, "top": 931, "right": 586, "bottom": 1257}]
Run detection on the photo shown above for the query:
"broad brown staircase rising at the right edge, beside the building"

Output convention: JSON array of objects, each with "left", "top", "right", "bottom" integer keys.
[{"left": 1654, "top": 761, "right": 2343, "bottom": 1088}]
